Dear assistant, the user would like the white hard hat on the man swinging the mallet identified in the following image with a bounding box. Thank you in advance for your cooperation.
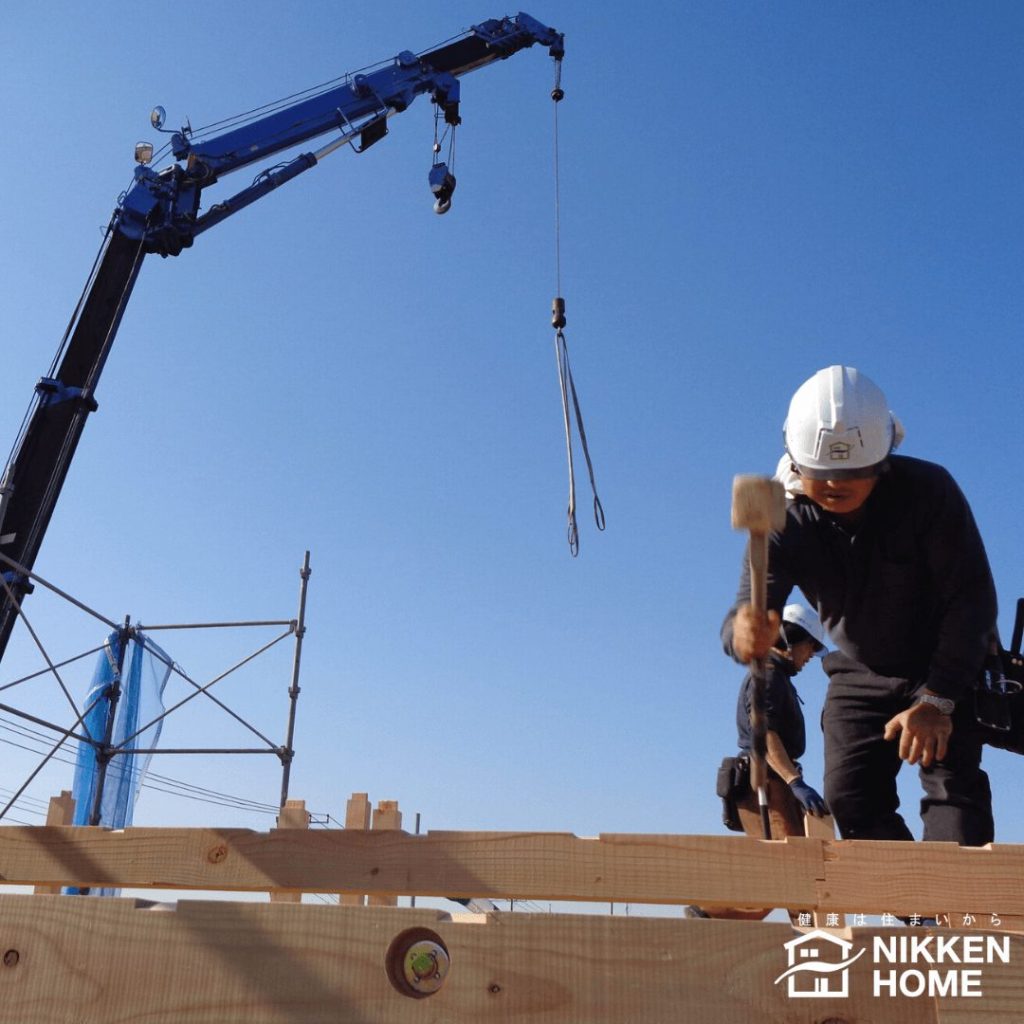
[782,367,903,480]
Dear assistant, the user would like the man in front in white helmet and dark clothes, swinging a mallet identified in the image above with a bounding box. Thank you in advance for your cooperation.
[722,366,996,846]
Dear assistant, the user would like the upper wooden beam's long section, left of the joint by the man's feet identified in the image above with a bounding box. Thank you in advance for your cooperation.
[0,825,822,906]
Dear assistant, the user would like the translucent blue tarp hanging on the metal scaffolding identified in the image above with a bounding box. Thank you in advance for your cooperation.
[66,632,172,894]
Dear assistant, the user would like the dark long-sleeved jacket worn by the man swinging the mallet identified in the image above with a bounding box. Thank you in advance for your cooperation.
[722,456,996,699]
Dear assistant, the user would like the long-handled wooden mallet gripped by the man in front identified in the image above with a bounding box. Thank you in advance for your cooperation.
[732,475,785,839]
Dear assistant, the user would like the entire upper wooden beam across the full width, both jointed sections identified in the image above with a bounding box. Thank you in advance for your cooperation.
[0,825,1024,919]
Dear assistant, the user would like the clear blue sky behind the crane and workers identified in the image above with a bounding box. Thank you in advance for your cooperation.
[0,0,1024,864]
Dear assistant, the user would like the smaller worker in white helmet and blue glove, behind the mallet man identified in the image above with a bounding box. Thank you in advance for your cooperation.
[736,604,828,839]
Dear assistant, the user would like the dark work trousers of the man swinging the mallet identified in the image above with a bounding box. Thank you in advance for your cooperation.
[821,652,994,846]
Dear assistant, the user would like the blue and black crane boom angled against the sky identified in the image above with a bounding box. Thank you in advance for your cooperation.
[0,13,564,658]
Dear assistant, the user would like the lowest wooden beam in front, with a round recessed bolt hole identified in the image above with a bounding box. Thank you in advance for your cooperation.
[6,895,1024,1024]
